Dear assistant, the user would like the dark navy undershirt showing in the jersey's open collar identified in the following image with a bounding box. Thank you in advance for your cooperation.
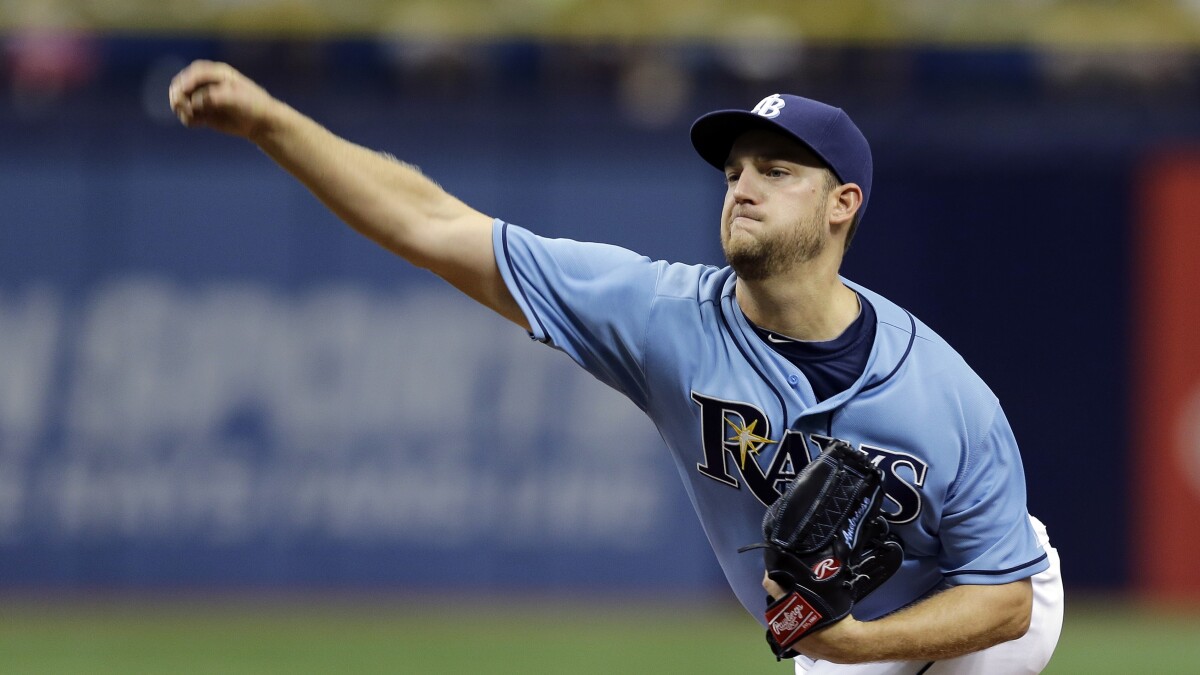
[746,295,875,401]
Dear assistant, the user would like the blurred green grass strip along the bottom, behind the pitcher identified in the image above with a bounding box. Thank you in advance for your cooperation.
[0,595,1200,675]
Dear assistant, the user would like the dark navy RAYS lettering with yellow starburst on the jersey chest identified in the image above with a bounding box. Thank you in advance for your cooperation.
[691,392,929,516]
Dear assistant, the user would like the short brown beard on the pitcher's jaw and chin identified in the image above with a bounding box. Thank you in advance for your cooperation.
[721,205,829,281]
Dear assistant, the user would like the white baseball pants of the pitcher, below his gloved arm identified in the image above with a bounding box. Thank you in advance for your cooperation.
[794,516,1063,675]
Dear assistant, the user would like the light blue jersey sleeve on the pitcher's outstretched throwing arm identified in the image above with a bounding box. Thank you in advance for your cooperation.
[492,220,665,410]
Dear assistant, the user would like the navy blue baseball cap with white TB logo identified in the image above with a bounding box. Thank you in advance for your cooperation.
[691,94,871,217]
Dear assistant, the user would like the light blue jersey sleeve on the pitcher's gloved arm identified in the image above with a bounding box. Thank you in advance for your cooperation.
[940,404,1050,585]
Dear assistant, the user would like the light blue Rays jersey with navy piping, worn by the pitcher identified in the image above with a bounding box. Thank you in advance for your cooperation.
[493,221,1049,621]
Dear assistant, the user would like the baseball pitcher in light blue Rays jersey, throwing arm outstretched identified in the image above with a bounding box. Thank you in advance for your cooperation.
[169,61,1063,675]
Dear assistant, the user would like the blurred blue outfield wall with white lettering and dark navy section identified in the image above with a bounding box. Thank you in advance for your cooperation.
[0,42,1198,591]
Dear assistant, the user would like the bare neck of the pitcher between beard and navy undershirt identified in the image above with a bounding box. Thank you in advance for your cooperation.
[736,265,859,341]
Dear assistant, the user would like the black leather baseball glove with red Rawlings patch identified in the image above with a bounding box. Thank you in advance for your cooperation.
[738,441,904,659]
